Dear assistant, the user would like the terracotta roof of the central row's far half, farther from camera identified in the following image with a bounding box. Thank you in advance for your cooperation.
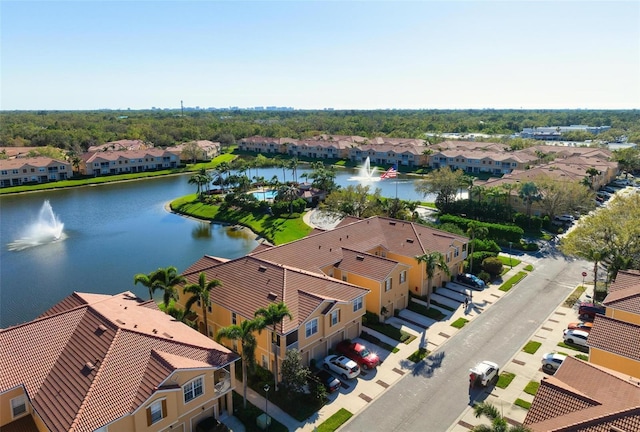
[253,216,468,272]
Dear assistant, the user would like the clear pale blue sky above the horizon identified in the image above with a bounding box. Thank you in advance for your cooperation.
[0,0,640,110]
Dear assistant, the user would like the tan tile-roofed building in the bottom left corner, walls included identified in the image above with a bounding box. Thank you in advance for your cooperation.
[0,292,238,432]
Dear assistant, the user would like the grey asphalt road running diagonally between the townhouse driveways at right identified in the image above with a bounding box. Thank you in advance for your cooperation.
[340,250,589,432]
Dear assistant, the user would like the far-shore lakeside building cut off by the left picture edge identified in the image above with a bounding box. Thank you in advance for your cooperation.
[0,156,73,187]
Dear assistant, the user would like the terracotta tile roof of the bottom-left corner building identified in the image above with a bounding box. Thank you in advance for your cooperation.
[0,292,238,431]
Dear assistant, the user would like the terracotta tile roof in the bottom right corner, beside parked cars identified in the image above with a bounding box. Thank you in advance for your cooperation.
[524,356,640,432]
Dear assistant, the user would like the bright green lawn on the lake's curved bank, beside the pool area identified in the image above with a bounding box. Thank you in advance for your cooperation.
[171,194,312,245]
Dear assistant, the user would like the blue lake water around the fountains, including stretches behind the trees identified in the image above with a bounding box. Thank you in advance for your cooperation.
[0,168,436,328]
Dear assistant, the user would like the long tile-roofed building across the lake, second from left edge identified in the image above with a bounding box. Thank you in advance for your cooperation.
[80,149,180,177]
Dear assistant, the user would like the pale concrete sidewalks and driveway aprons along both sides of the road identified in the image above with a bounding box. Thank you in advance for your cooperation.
[233,262,540,432]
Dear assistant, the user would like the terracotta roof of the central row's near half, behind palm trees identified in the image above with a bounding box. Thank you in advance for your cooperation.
[184,255,369,334]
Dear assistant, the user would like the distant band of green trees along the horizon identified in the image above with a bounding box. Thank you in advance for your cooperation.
[0,110,640,154]
